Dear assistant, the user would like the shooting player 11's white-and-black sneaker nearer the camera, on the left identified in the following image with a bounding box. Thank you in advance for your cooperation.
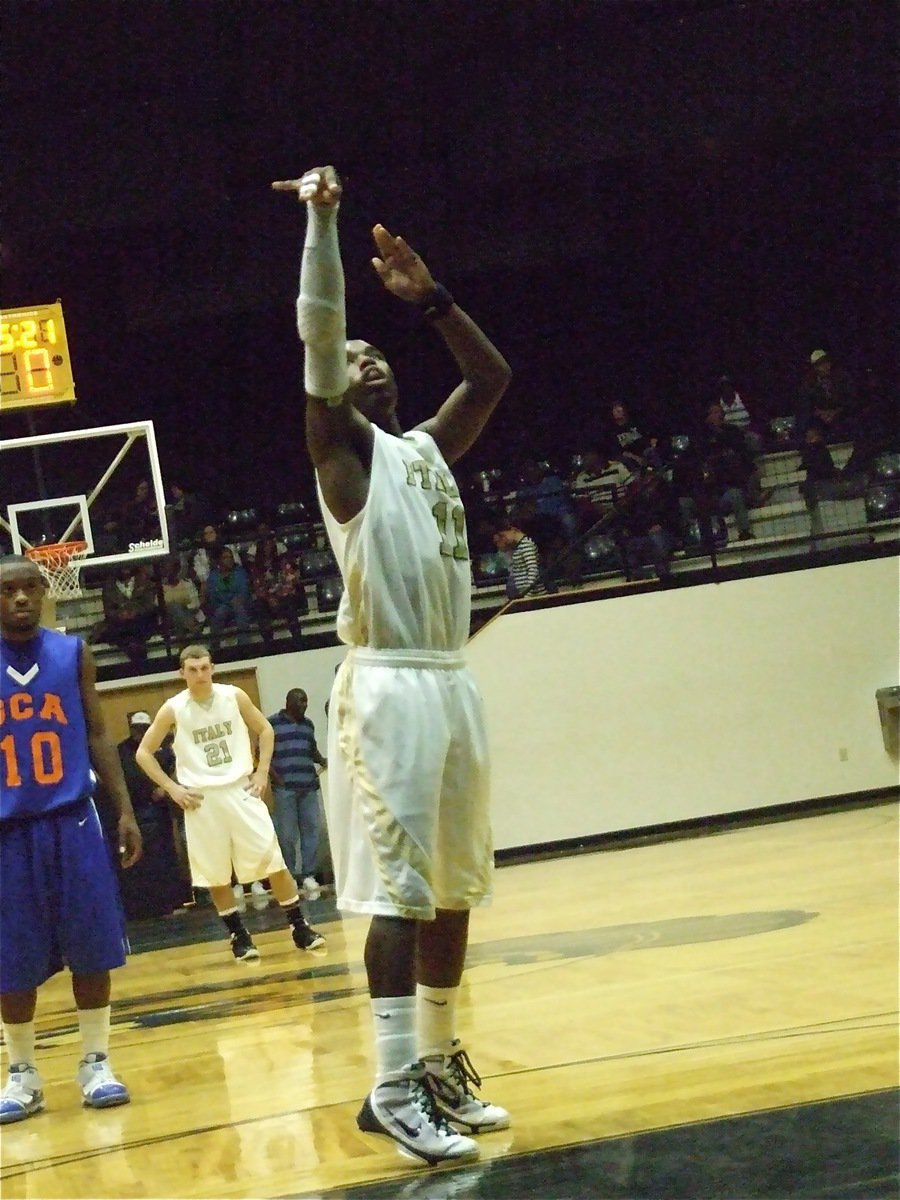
[356,1062,479,1165]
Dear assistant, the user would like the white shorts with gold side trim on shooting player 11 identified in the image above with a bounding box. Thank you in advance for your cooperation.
[325,647,493,920]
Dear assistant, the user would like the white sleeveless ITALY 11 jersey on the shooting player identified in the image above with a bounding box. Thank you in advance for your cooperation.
[319,425,472,650]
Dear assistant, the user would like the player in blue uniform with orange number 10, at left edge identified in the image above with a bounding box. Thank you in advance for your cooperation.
[0,554,140,1124]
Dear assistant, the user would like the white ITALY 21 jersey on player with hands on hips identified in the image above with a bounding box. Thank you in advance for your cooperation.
[169,683,253,787]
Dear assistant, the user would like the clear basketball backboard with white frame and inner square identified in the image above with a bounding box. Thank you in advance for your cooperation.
[0,421,169,566]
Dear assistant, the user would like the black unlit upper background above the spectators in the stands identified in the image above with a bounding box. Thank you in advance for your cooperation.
[0,0,898,506]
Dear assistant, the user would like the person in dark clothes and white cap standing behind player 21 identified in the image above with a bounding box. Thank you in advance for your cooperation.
[118,712,191,920]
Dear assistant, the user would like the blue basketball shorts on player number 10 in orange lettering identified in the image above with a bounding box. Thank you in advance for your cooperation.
[0,798,128,992]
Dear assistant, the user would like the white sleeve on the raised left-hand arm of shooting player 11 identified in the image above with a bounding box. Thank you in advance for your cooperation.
[296,204,348,398]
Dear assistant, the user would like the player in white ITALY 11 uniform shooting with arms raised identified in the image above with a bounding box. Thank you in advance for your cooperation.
[274,167,510,1163]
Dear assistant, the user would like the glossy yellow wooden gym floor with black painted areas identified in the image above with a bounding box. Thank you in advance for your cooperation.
[0,803,899,1200]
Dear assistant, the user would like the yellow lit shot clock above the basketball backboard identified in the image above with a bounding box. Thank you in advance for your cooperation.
[0,301,76,413]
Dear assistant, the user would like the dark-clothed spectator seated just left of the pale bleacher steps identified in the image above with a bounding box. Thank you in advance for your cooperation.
[672,401,755,541]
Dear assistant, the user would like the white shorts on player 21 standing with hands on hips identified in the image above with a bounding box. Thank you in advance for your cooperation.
[185,780,284,888]
